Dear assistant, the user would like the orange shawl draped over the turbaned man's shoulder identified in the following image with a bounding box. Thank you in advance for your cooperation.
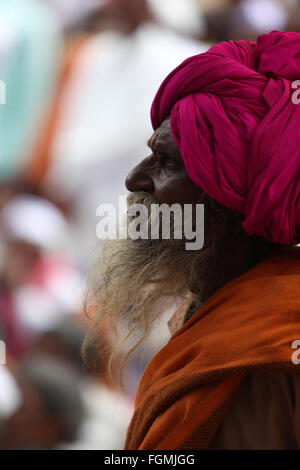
[125,247,300,450]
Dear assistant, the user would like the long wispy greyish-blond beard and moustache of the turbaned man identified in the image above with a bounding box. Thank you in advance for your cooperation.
[88,193,213,362]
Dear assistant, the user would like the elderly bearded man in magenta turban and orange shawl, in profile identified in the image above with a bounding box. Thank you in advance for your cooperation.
[91,31,300,450]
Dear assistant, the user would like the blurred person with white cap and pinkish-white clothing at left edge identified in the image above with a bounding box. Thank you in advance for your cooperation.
[0,194,82,358]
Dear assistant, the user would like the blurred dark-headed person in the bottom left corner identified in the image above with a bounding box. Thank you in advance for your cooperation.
[0,357,85,450]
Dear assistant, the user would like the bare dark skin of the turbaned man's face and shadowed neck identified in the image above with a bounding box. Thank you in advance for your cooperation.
[126,120,278,302]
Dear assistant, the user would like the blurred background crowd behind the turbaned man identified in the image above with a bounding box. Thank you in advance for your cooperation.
[0,0,300,449]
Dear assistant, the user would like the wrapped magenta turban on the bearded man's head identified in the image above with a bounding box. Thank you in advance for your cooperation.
[151,31,300,245]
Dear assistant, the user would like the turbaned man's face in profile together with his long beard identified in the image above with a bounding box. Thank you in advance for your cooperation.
[88,121,213,360]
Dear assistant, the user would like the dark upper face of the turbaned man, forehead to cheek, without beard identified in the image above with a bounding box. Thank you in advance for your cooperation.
[126,120,203,205]
